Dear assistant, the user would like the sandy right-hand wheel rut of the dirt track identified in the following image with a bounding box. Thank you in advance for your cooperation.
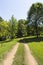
[24,44,38,65]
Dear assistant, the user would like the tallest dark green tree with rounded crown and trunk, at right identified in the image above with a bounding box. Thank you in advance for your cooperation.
[27,3,43,38]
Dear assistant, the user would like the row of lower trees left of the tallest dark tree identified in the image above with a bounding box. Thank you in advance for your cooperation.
[0,15,27,41]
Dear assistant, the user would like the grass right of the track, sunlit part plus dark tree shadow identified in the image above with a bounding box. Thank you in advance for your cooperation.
[19,36,43,65]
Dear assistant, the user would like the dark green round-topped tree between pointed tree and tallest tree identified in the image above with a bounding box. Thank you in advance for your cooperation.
[17,19,27,37]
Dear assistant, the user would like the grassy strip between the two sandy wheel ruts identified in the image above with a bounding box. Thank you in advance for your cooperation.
[12,43,25,65]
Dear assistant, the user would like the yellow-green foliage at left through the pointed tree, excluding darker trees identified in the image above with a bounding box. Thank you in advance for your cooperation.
[0,16,17,41]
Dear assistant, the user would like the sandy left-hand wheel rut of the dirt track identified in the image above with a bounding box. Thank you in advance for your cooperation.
[2,43,19,65]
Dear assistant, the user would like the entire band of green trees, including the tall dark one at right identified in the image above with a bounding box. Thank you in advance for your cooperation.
[0,3,43,41]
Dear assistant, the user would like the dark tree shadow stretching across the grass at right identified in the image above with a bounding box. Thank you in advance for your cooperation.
[18,37,43,43]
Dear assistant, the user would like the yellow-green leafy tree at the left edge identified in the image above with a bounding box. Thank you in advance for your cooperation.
[0,21,8,40]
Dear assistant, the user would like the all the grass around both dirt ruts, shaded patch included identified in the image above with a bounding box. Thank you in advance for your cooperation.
[0,36,43,65]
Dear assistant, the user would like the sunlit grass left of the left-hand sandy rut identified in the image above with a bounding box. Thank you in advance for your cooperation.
[0,39,17,63]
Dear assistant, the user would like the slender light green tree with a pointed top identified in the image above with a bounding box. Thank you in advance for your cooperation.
[10,15,17,39]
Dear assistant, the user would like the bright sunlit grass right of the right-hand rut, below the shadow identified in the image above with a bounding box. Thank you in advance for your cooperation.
[28,41,43,65]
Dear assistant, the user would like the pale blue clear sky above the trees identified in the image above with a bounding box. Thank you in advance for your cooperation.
[0,0,43,20]
